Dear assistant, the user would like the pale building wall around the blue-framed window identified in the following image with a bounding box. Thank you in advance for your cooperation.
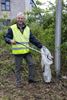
[0,0,25,19]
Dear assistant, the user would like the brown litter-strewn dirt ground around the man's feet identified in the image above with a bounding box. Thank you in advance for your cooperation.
[0,50,67,100]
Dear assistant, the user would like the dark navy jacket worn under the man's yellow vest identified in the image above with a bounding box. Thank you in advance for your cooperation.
[5,25,42,48]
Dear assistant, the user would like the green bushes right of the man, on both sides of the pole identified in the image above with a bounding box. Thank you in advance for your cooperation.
[27,2,67,67]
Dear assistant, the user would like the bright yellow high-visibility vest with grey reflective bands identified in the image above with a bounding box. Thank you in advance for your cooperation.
[11,24,30,54]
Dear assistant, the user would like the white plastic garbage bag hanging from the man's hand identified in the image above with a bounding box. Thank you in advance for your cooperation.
[41,46,53,83]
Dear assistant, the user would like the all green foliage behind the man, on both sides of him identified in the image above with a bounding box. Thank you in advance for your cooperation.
[0,0,67,76]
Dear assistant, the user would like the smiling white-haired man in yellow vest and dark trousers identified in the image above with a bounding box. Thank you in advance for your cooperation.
[5,12,42,87]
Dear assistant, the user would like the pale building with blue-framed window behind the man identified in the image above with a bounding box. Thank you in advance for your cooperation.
[0,0,33,19]
